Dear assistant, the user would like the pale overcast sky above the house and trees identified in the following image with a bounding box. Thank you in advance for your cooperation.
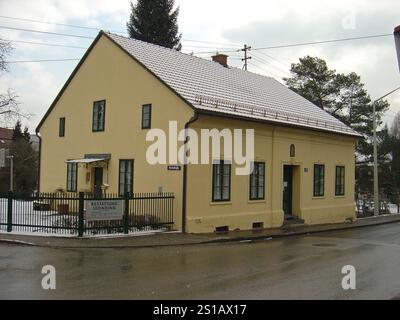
[0,0,400,132]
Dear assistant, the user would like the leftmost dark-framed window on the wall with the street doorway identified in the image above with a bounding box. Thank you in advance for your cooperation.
[212,161,231,202]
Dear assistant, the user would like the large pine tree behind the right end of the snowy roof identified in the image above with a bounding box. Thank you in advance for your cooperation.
[284,56,389,162]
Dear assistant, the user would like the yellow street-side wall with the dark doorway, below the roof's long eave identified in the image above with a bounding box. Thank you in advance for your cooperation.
[187,116,356,233]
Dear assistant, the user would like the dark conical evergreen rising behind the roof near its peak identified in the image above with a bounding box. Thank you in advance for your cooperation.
[127,0,182,51]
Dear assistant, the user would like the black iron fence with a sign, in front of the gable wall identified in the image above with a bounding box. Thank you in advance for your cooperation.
[0,192,174,237]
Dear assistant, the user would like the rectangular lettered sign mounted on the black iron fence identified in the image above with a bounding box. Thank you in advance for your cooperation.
[86,199,124,221]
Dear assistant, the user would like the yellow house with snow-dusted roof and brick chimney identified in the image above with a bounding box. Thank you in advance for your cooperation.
[37,32,358,233]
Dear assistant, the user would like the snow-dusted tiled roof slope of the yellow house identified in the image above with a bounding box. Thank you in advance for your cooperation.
[105,33,358,136]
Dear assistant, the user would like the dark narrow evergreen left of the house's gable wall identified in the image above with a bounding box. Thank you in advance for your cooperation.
[10,121,37,193]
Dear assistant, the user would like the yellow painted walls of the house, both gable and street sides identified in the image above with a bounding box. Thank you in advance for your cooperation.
[40,36,355,233]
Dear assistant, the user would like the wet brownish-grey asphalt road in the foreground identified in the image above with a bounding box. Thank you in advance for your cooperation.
[0,223,400,299]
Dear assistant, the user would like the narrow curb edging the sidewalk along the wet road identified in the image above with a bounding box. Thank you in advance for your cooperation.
[0,217,400,249]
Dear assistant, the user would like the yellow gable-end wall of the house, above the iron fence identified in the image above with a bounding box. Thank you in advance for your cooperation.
[40,36,193,229]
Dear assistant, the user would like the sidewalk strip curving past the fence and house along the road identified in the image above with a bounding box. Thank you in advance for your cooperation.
[0,214,400,249]
